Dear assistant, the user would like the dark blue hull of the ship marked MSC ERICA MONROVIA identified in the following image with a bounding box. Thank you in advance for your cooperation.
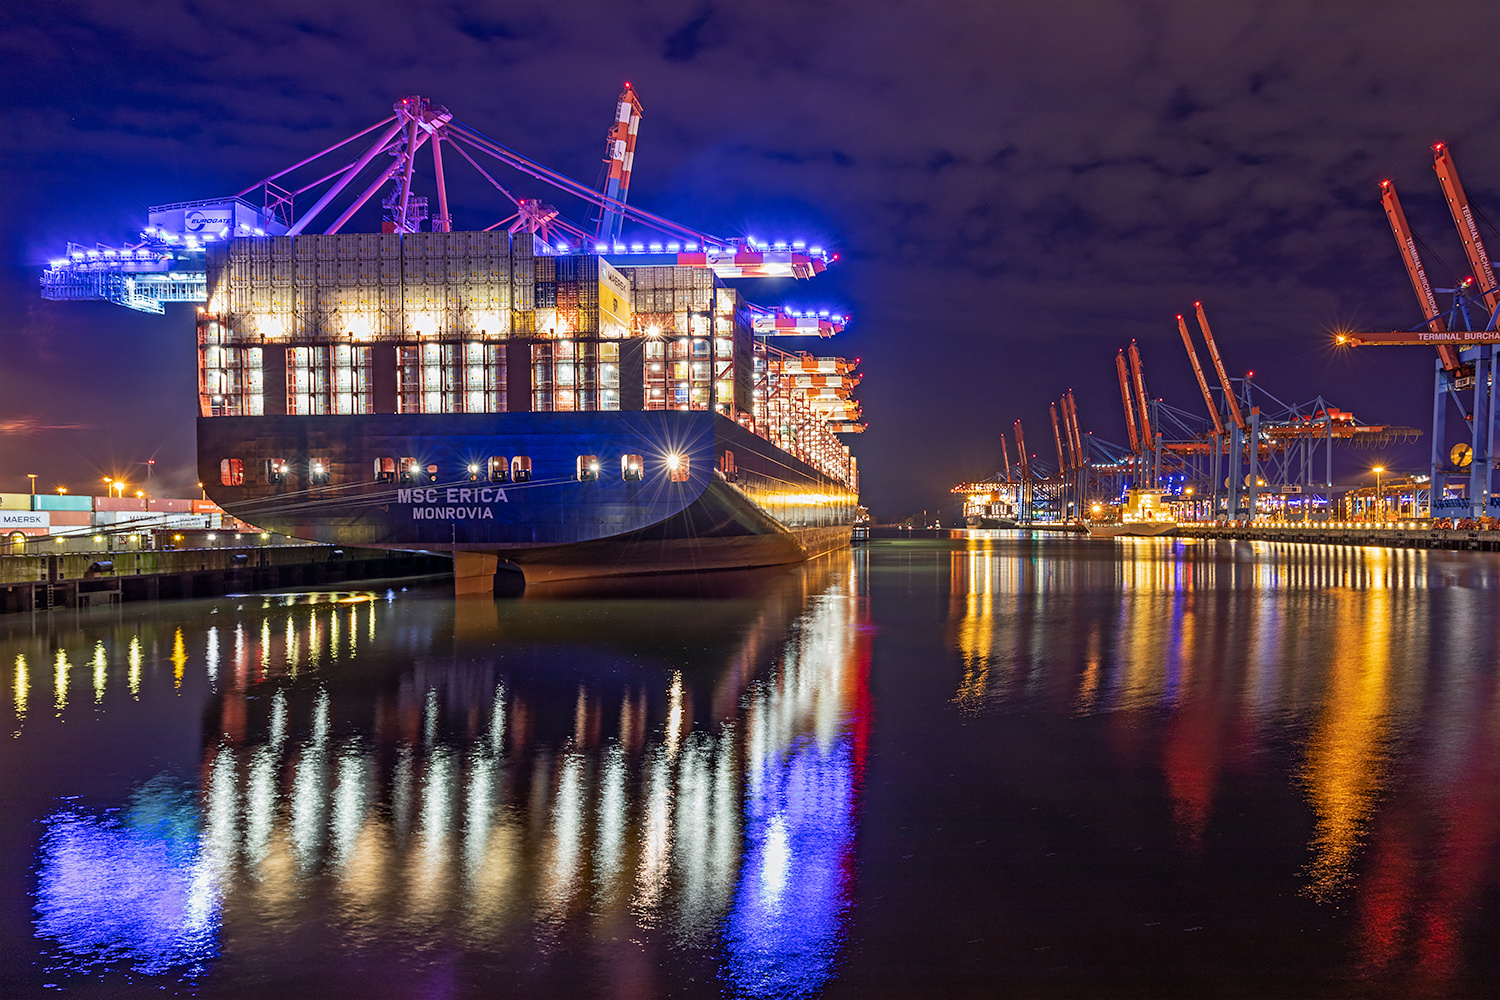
[198,411,858,582]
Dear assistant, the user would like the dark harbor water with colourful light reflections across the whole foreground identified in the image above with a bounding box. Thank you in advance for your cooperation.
[0,531,1500,1000]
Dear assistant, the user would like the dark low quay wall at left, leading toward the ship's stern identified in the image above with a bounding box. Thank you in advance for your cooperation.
[0,546,453,613]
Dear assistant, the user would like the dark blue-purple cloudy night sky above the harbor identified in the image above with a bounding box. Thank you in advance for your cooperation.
[0,0,1500,519]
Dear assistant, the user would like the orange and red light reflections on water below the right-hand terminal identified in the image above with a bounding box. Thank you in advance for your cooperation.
[948,537,1500,991]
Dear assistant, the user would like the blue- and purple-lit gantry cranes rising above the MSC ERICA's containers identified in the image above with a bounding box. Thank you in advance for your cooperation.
[41,84,837,310]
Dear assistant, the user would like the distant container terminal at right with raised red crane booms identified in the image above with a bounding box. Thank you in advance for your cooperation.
[953,144,1500,549]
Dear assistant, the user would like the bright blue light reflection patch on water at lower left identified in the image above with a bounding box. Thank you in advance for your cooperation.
[35,780,219,976]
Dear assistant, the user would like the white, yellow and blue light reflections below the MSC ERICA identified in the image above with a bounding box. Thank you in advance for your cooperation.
[15,555,869,996]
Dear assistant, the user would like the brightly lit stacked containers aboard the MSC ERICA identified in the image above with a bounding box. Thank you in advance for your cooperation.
[198,232,858,481]
